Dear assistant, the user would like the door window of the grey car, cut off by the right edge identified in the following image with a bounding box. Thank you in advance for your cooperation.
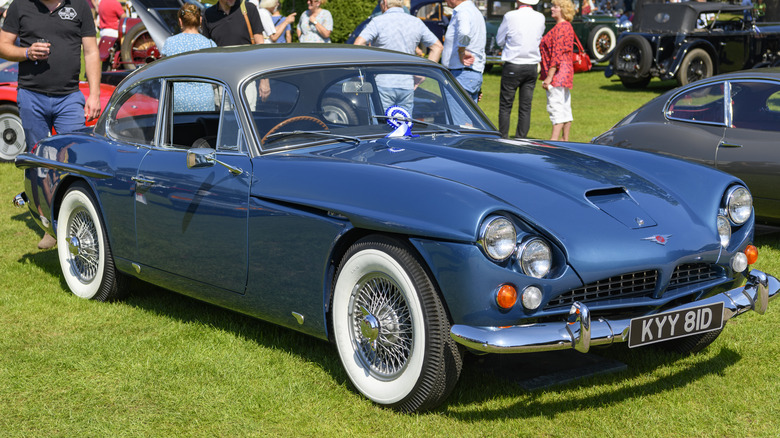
[731,81,780,131]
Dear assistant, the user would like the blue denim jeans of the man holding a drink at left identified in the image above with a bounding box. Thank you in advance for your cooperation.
[16,88,86,151]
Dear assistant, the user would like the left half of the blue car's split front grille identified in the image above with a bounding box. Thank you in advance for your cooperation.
[546,270,658,308]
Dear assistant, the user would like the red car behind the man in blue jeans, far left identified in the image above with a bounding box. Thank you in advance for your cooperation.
[0,61,115,161]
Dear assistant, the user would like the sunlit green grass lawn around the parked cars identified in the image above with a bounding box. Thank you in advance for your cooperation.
[0,68,780,437]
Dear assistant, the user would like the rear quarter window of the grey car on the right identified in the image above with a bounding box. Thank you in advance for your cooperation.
[666,83,725,125]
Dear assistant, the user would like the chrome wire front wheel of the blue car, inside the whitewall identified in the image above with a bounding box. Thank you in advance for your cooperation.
[349,275,414,380]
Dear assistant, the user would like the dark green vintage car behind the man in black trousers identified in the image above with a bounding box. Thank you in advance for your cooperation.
[485,0,631,65]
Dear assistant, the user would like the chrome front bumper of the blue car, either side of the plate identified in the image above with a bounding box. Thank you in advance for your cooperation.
[450,270,780,353]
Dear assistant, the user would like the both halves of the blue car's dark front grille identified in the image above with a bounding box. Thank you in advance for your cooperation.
[545,263,720,309]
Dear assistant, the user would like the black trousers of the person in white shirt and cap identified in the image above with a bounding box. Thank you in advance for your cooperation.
[498,62,536,138]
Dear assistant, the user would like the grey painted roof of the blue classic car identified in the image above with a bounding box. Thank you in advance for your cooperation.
[115,44,443,94]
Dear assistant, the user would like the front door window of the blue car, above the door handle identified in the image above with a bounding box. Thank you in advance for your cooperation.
[163,80,233,149]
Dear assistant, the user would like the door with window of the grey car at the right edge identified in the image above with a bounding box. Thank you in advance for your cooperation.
[717,80,780,218]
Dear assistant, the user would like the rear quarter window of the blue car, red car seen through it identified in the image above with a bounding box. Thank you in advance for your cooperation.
[107,79,162,145]
